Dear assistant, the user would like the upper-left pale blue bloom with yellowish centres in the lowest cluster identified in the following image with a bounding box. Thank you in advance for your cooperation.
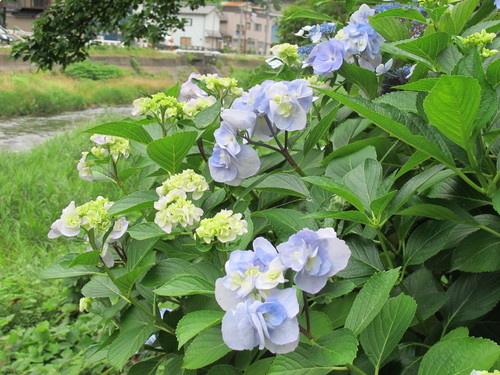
[215,237,286,310]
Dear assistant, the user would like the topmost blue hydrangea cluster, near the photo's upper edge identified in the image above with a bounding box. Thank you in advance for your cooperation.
[299,4,392,77]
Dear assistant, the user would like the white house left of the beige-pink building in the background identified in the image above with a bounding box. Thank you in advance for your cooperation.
[171,4,224,50]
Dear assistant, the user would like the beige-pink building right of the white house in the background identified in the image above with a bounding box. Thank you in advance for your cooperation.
[221,1,281,55]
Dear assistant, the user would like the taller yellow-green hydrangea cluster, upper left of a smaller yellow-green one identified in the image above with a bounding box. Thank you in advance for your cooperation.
[154,169,208,233]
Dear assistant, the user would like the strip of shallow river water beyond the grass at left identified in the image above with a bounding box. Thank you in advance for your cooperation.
[0,107,132,151]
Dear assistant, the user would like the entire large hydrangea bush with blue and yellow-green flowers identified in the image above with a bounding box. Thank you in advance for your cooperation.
[43,0,500,375]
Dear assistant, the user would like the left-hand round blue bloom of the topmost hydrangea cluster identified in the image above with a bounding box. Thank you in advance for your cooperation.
[305,39,345,77]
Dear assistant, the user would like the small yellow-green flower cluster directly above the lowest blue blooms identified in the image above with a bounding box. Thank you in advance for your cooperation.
[196,210,248,243]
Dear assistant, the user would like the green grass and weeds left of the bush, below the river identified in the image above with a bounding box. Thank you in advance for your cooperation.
[0,118,124,375]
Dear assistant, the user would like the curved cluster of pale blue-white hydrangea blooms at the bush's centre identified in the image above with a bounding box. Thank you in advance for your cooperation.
[208,79,313,186]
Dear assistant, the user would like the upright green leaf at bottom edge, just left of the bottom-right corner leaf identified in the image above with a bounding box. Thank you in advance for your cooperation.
[359,294,417,369]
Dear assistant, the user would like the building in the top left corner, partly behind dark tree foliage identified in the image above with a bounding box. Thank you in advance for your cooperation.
[0,0,53,31]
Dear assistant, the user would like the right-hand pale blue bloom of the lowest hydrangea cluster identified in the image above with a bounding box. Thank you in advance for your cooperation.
[278,228,351,294]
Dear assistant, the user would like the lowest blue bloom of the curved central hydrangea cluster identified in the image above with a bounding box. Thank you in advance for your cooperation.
[208,144,260,186]
